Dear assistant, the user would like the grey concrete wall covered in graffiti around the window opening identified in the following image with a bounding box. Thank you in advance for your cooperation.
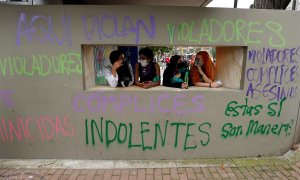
[0,6,300,159]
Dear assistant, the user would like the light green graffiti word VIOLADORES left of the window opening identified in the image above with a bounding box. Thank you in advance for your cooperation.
[0,52,82,77]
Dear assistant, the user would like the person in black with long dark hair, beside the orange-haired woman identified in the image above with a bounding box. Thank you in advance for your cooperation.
[163,55,189,89]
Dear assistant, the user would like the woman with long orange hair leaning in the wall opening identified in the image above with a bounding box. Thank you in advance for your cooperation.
[190,51,221,88]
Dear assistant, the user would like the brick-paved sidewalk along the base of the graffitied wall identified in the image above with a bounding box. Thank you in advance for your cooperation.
[0,144,300,180]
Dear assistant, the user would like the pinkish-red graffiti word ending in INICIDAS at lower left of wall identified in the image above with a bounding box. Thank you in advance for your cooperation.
[0,115,76,143]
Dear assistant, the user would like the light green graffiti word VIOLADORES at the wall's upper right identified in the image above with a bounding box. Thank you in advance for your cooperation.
[167,18,286,48]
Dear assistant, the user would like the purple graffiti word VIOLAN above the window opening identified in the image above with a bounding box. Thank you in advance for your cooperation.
[82,15,156,43]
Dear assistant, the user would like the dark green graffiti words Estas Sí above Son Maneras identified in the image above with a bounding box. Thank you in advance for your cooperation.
[225,98,286,117]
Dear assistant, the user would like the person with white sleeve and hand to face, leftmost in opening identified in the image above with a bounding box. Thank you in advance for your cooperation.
[104,50,134,88]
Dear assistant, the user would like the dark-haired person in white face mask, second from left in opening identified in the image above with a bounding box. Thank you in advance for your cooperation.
[134,47,160,89]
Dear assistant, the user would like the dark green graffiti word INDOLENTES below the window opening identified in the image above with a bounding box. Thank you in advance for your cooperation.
[85,117,212,151]
